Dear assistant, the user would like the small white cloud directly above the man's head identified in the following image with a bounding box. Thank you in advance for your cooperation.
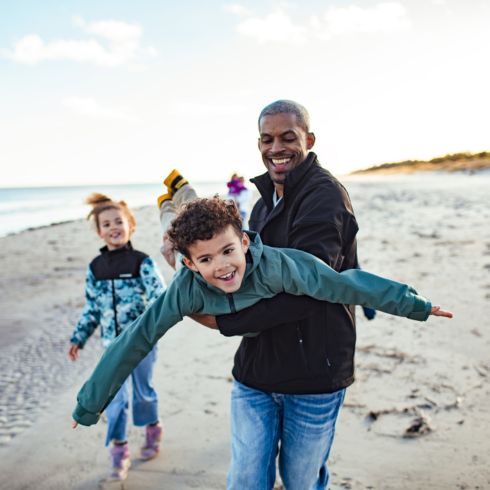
[236,10,305,44]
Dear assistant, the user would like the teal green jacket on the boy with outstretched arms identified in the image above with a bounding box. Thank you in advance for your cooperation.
[73,232,431,425]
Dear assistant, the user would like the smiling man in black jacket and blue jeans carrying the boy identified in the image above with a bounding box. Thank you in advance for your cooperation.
[217,100,358,490]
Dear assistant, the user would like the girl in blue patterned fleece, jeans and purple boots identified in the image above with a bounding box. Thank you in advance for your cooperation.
[68,193,164,480]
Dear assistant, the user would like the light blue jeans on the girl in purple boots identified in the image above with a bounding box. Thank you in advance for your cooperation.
[105,347,158,446]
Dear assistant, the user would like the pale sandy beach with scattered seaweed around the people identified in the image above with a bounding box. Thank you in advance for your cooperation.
[0,174,490,490]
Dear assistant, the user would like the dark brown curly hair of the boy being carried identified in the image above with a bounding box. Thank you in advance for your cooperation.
[167,196,243,258]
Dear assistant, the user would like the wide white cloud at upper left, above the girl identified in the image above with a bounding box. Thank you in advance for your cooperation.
[2,17,156,67]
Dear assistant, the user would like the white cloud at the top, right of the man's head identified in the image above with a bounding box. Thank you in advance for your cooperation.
[312,2,410,38]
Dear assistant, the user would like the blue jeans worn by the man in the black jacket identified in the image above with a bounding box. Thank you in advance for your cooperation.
[227,381,345,490]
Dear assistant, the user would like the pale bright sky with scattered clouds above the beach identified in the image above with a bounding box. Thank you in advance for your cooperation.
[0,0,490,186]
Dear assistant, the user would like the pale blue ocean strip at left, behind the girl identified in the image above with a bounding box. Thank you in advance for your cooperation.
[0,182,227,237]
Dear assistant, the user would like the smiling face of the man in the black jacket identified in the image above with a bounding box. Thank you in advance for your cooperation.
[259,113,315,195]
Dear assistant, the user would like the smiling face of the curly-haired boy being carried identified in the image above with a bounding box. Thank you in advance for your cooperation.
[184,225,250,293]
